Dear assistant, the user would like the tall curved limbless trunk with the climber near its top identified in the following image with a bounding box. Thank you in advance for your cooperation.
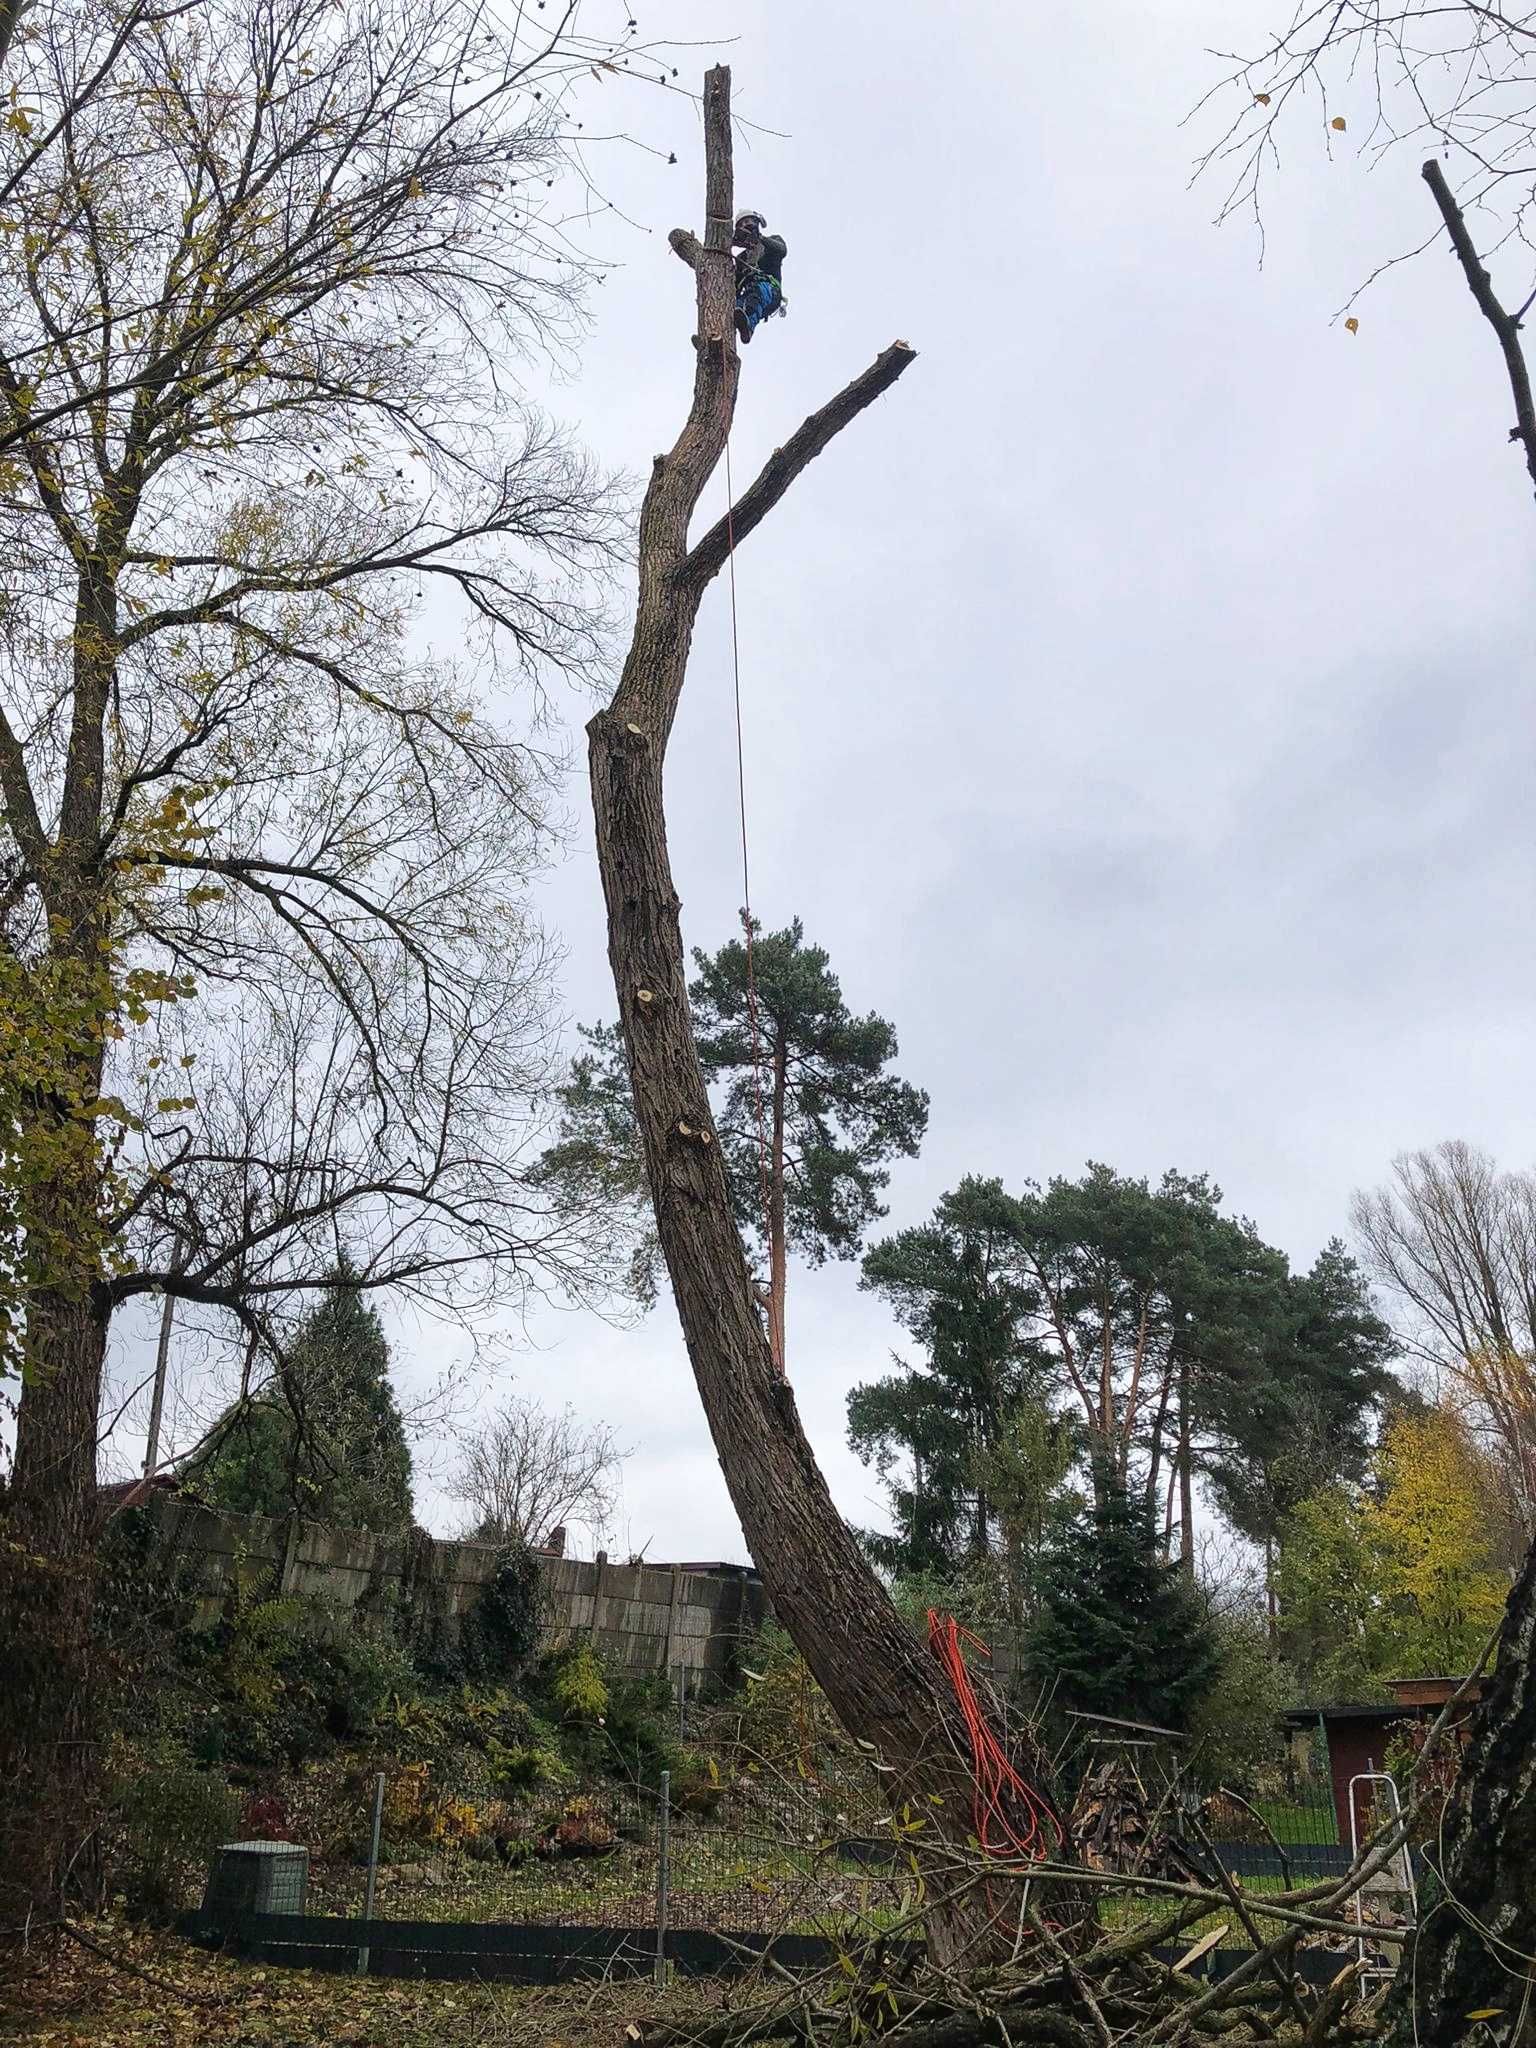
[588,68,1048,1956]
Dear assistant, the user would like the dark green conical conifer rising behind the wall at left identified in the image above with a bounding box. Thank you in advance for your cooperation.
[188,1264,412,1534]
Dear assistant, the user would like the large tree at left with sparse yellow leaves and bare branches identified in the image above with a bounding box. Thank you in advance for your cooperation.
[0,0,675,1896]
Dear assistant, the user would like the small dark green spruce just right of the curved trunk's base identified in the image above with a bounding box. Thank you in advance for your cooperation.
[1028,1464,1221,1729]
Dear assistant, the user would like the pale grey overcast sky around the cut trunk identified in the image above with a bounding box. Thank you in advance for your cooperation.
[108,0,1536,1559]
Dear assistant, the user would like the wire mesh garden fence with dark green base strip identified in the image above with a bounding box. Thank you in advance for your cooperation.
[171,1708,1392,1980]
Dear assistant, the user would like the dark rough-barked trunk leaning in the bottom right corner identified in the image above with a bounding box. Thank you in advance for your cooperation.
[1382,1546,1536,2048]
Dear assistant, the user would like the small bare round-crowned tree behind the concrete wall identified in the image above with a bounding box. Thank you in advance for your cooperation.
[449,1399,625,1544]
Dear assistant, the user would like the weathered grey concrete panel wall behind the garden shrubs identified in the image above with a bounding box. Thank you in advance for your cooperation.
[154,1499,764,1690]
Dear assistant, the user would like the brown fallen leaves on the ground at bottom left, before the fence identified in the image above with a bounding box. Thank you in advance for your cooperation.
[0,1921,721,2048]
